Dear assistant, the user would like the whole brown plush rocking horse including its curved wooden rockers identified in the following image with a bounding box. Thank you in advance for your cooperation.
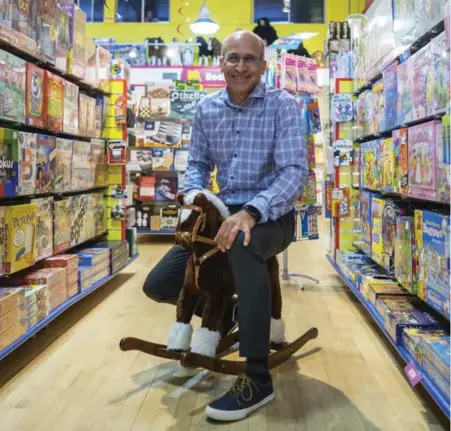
[120,190,318,375]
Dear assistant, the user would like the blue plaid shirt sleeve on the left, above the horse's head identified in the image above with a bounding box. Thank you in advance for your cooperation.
[183,103,214,193]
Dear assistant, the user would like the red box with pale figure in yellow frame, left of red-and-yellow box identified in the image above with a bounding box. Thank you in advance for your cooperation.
[25,63,45,128]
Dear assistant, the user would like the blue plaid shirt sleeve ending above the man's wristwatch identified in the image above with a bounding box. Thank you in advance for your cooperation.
[248,97,308,223]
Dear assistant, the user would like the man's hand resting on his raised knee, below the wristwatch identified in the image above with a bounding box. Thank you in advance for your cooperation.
[215,210,256,252]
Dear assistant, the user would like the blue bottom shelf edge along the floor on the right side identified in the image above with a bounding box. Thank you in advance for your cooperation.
[326,254,450,419]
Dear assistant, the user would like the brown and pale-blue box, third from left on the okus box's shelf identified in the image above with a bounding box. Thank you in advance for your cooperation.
[36,134,56,194]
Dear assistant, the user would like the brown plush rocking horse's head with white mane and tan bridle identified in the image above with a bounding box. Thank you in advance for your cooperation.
[175,190,229,248]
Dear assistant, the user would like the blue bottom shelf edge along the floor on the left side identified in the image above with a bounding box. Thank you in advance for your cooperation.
[0,254,139,360]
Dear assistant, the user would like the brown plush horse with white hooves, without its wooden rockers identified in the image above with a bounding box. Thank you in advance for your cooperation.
[167,190,285,357]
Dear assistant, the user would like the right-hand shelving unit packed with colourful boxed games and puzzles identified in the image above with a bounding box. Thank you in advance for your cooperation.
[325,0,451,418]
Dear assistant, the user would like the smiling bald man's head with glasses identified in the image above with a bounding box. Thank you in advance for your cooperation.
[221,36,266,98]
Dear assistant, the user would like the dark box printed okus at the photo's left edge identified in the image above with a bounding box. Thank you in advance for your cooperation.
[0,128,19,197]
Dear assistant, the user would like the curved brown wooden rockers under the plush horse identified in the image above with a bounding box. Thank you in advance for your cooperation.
[119,328,318,375]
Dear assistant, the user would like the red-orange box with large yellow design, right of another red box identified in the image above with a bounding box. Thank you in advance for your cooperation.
[44,71,65,132]
